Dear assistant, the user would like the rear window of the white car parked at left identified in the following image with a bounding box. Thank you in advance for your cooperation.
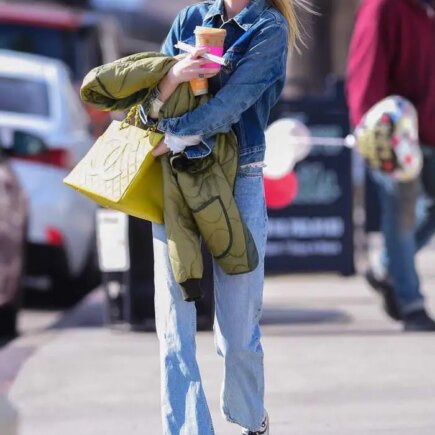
[0,76,50,117]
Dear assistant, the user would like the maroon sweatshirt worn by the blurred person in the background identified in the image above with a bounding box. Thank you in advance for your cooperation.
[347,0,435,146]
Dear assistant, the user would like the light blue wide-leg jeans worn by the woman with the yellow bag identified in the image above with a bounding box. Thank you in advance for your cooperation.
[153,167,267,435]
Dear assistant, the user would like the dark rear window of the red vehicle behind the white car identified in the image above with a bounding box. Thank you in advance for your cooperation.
[0,23,78,80]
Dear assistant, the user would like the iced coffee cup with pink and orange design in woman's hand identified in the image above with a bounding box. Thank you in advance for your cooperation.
[190,26,227,96]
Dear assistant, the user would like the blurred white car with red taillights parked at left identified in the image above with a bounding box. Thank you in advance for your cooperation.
[0,50,97,299]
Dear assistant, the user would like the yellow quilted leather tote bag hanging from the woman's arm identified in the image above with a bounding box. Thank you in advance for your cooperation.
[63,109,163,223]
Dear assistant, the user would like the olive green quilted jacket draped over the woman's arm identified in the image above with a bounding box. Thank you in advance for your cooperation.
[81,53,258,301]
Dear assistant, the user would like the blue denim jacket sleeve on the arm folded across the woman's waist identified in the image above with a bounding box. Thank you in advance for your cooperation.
[158,22,288,157]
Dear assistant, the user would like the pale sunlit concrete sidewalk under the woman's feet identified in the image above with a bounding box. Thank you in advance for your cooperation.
[2,248,435,435]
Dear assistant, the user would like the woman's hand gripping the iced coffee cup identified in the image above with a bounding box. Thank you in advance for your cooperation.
[168,48,220,85]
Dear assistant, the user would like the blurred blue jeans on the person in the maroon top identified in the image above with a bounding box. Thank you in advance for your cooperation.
[372,147,435,314]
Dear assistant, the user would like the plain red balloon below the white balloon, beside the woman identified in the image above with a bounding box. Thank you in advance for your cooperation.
[264,172,299,208]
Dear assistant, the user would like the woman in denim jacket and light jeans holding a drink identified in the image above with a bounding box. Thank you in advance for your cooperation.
[141,0,300,435]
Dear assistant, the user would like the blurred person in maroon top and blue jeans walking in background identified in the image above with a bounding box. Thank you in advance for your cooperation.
[347,0,435,331]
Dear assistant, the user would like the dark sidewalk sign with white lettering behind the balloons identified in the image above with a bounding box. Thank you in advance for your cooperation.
[266,85,355,275]
